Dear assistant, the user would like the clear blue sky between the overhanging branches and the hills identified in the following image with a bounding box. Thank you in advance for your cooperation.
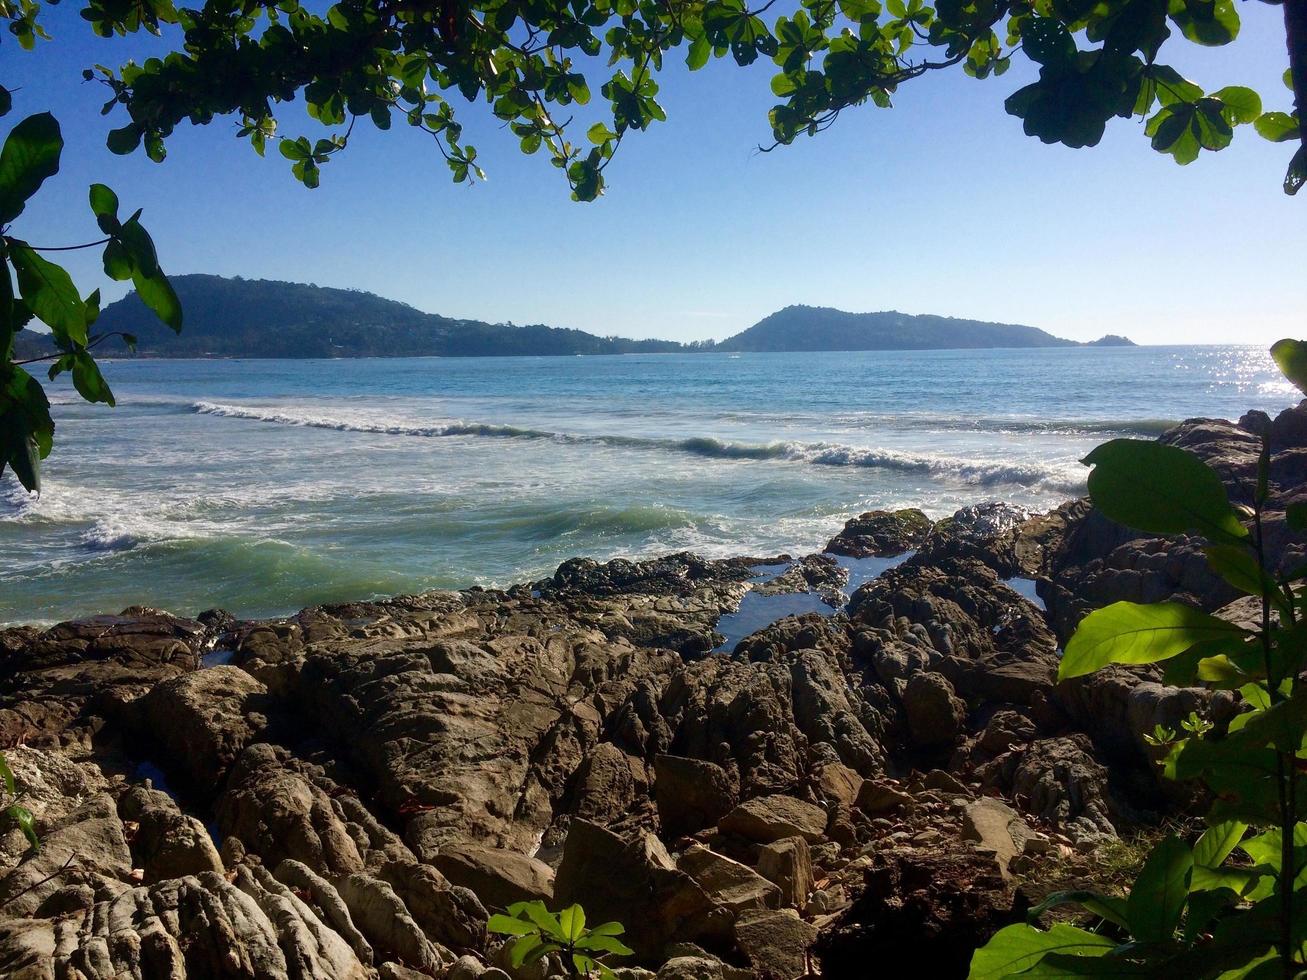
[0,3,1307,344]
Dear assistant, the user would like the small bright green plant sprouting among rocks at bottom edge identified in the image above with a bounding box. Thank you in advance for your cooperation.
[486,902,634,980]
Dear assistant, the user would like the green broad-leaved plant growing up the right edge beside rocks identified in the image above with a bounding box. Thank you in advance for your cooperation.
[971,342,1307,977]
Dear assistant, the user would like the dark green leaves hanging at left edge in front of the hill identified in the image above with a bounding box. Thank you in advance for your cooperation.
[0,101,182,491]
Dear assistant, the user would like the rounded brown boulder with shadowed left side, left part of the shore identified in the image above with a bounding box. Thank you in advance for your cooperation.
[137,666,272,794]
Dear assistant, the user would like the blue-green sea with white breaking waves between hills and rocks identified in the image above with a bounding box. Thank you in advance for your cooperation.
[0,346,1298,623]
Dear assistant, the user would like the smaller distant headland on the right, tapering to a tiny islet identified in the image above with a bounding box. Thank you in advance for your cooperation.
[714,306,1134,351]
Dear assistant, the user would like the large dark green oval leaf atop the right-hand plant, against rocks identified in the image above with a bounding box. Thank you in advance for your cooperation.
[1085,439,1248,541]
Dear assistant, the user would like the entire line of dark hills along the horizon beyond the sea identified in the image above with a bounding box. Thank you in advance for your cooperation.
[18,273,1133,358]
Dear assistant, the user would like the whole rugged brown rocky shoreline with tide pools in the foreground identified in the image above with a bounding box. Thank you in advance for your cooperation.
[0,406,1307,980]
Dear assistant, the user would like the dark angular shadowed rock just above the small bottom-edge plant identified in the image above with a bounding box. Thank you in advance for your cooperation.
[554,819,731,959]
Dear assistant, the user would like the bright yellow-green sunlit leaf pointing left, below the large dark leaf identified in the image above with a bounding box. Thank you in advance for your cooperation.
[1057,602,1246,681]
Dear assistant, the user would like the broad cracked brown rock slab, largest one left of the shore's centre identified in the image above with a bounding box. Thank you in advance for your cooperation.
[298,593,680,861]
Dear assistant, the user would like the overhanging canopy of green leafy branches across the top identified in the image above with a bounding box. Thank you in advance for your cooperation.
[0,0,1307,200]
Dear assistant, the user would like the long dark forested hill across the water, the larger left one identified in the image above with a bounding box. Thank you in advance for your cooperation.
[95,276,689,358]
